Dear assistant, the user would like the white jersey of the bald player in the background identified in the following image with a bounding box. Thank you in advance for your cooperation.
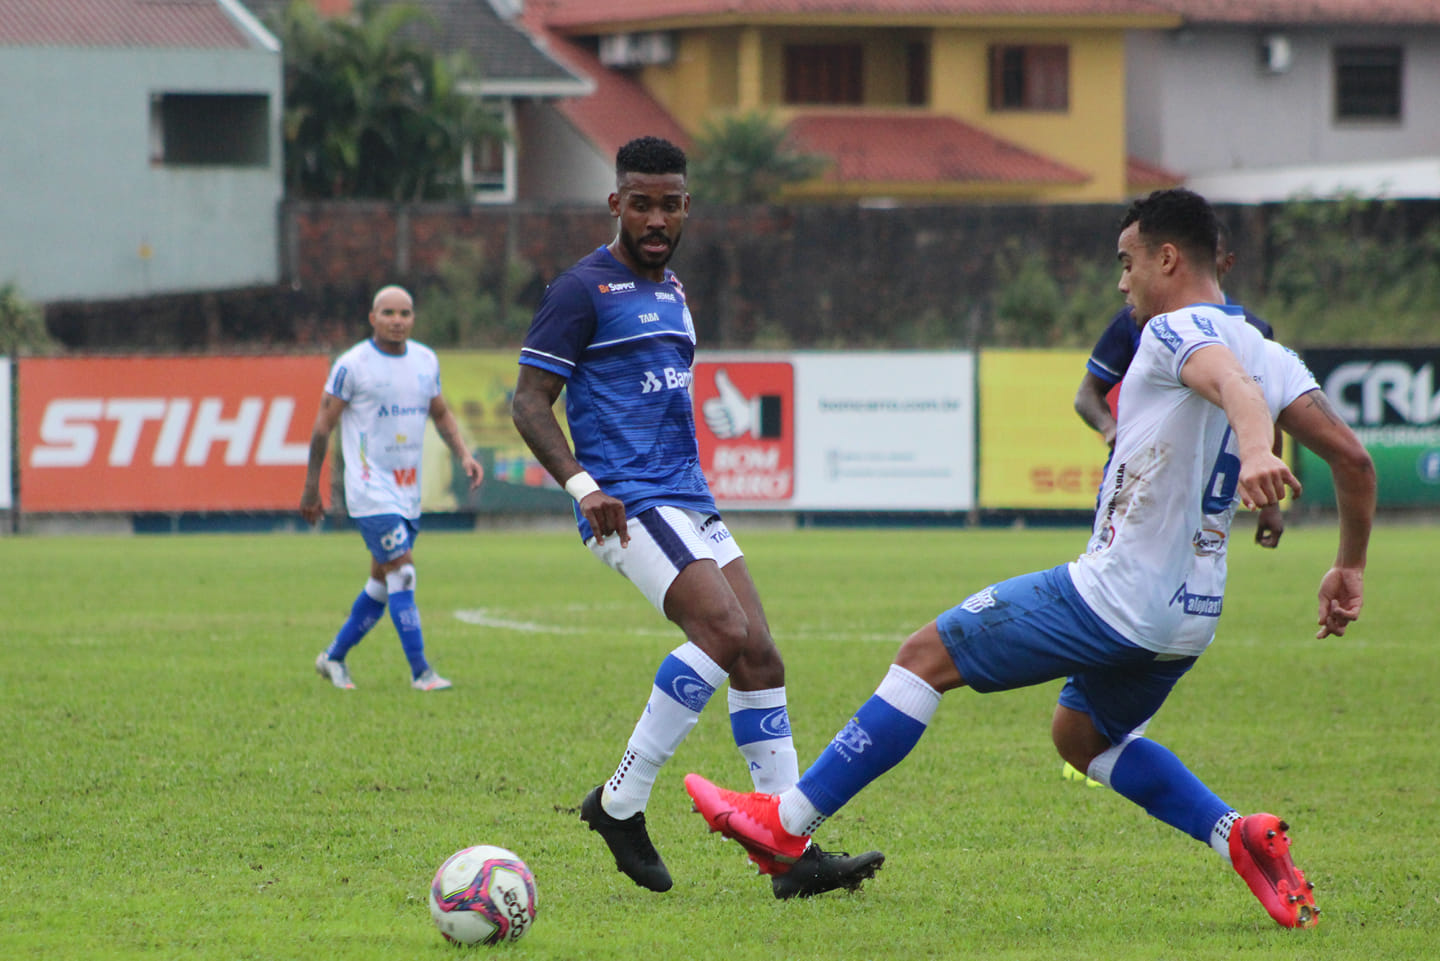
[325,340,441,519]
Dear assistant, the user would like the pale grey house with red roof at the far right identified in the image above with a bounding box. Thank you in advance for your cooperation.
[1125,0,1440,203]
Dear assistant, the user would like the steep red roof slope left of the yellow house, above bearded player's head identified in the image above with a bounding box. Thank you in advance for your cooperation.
[530,23,691,157]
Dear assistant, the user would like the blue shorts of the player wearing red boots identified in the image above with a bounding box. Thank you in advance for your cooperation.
[936,565,1195,743]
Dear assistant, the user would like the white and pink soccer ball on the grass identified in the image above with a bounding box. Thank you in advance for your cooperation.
[431,844,536,944]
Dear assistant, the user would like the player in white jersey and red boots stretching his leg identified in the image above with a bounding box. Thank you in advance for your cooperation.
[685,190,1375,928]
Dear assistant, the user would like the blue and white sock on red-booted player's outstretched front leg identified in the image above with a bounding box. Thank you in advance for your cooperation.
[780,664,940,836]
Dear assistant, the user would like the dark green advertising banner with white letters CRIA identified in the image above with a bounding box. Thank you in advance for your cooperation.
[1297,347,1440,507]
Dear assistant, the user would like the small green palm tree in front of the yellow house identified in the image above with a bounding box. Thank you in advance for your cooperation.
[690,111,829,203]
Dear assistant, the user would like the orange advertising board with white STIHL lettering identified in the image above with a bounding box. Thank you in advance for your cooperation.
[19,354,330,511]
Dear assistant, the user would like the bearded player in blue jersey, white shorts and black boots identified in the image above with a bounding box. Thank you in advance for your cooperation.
[513,137,884,898]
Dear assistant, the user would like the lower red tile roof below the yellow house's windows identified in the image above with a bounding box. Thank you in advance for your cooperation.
[789,112,1089,184]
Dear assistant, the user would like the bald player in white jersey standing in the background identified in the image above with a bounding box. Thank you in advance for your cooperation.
[300,287,484,690]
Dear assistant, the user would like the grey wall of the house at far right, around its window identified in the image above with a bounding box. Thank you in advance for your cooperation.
[1126,27,1440,174]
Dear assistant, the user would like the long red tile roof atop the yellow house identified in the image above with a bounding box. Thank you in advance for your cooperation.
[538,0,1169,30]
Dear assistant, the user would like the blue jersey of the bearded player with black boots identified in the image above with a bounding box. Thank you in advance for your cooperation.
[520,246,716,540]
